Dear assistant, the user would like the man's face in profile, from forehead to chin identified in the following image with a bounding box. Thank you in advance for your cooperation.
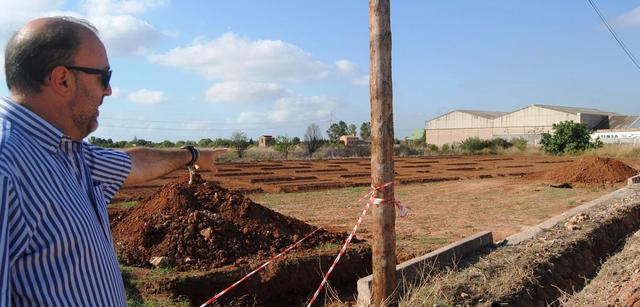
[70,35,111,138]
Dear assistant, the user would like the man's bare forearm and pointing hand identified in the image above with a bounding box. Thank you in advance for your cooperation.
[124,147,227,185]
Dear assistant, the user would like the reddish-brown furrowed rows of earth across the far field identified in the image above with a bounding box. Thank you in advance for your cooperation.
[113,156,616,203]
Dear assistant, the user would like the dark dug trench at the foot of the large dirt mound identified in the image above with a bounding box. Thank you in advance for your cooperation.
[168,243,371,307]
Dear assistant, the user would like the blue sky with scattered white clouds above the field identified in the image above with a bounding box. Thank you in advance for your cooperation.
[0,0,640,142]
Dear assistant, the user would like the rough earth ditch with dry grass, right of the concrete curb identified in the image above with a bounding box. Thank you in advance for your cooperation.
[427,184,640,306]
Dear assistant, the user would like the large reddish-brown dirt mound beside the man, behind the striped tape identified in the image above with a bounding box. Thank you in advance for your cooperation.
[112,176,347,271]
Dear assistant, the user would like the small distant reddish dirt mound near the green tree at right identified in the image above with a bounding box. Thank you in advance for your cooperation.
[529,156,637,186]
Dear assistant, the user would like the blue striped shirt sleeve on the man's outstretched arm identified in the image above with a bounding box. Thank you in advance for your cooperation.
[83,143,131,203]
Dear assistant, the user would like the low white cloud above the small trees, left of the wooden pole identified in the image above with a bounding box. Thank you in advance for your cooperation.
[236,96,338,124]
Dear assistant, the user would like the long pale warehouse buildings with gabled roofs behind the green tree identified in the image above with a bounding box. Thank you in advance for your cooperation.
[425,104,640,146]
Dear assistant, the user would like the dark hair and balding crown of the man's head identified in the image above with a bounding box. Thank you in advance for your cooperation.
[4,17,97,96]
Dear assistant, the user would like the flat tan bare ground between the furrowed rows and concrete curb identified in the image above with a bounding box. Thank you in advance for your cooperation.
[251,178,613,262]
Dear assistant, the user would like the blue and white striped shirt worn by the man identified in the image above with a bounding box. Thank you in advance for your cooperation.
[0,97,131,306]
